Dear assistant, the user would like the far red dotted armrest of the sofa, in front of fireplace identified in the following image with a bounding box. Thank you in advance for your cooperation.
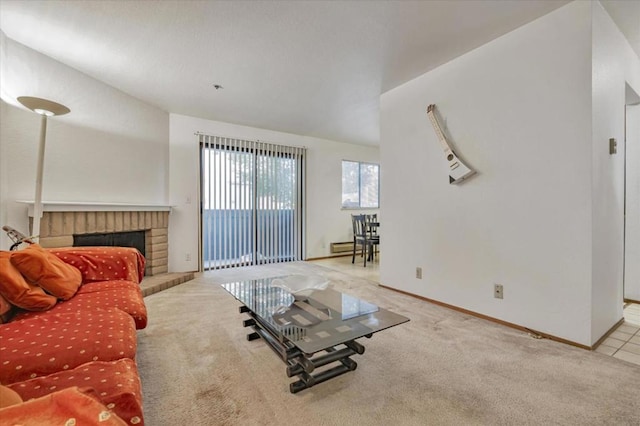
[48,247,145,283]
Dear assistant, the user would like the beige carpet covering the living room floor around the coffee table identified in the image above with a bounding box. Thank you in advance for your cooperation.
[137,262,640,426]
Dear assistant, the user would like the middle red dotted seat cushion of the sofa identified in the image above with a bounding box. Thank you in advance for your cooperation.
[0,308,137,385]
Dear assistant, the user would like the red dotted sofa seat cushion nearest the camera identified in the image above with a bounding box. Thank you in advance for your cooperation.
[9,358,143,425]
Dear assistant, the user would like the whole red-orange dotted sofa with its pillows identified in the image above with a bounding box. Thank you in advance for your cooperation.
[0,244,147,425]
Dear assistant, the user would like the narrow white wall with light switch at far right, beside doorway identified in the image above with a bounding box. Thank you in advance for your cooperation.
[591,2,640,342]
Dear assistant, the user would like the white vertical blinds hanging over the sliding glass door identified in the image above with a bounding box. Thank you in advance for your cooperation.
[198,134,306,269]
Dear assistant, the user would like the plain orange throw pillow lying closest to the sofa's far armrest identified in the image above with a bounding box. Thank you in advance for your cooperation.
[11,244,82,300]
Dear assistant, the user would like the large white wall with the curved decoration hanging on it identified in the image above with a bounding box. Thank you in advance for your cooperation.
[380,2,592,345]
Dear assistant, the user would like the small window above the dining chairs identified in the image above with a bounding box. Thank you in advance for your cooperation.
[342,160,380,209]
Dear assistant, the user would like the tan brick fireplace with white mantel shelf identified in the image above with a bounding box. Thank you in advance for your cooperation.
[25,203,171,275]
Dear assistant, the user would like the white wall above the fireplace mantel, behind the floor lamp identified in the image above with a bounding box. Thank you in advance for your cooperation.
[0,33,169,249]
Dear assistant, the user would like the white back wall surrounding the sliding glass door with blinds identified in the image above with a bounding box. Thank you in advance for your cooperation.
[169,114,379,272]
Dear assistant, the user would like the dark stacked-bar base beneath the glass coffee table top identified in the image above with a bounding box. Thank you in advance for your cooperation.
[240,306,372,393]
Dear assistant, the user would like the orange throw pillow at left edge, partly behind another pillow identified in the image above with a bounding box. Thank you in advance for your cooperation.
[0,251,57,311]
